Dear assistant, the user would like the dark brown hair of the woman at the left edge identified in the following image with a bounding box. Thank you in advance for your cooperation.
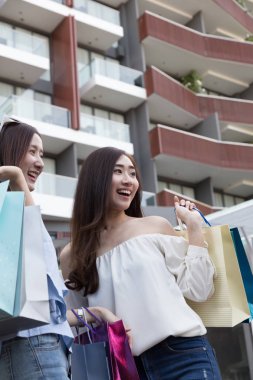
[0,119,40,166]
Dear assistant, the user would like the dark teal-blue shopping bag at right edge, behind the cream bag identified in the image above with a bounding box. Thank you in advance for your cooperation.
[230,227,253,321]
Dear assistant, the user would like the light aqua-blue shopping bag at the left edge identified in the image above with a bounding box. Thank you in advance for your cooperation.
[0,181,24,321]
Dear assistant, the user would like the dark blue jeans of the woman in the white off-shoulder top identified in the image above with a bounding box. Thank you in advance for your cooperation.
[135,336,221,380]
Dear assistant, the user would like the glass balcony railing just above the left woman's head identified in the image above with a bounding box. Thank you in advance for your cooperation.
[0,95,70,128]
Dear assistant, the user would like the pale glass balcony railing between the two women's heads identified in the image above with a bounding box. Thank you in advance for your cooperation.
[36,173,77,198]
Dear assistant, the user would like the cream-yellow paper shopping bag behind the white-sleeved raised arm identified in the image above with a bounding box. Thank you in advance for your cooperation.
[176,225,250,327]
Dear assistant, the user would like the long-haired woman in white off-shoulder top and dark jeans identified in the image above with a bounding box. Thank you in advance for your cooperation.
[61,147,221,380]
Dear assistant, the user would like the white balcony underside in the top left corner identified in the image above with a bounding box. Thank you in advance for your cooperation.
[0,0,70,33]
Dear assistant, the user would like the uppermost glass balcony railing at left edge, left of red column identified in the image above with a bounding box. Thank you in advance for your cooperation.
[0,22,49,58]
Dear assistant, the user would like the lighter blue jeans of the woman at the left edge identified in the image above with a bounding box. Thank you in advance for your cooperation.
[0,334,69,380]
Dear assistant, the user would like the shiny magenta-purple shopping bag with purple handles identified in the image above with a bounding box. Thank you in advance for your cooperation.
[72,307,140,380]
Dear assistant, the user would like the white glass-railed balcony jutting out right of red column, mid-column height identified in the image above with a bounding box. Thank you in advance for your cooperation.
[79,59,146,112]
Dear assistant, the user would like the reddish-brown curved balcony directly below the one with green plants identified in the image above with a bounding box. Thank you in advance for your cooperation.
[149,125,253,197]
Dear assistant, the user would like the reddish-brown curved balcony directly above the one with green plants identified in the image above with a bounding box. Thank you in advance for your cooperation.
[139,13,253,96]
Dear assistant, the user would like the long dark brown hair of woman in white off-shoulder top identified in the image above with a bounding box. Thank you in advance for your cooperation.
[67,147,142,296]
